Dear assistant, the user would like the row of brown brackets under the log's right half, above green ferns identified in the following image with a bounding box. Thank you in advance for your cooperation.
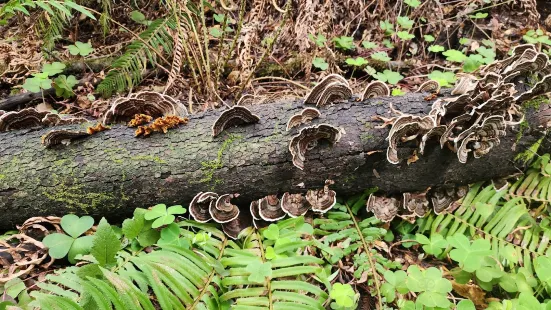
[366,186,469,222]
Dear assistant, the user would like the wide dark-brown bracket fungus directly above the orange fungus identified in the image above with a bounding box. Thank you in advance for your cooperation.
[103,91,188,124]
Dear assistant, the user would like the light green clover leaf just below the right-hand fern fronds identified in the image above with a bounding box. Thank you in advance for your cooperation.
[448,234,492,272]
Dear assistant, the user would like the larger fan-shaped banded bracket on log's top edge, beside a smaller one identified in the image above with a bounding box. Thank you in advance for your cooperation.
[304,74,352,107]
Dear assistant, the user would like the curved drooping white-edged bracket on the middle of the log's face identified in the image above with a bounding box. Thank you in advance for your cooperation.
[289,124,342,170]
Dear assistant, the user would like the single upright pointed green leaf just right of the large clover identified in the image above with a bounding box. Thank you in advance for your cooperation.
[90,218,121,267]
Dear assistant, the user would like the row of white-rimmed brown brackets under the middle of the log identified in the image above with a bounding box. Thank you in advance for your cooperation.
[189,180,337,239]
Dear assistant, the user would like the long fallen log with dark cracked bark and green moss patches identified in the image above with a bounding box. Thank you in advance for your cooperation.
[0,93,551,229]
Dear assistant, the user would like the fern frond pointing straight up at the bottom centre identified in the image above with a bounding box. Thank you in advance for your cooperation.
[220,218,328,310]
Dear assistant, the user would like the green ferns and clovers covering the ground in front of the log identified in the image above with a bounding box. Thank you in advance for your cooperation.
[0,155,551,309]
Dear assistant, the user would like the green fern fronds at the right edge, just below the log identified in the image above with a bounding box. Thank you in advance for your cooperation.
[418,155,551,271]
